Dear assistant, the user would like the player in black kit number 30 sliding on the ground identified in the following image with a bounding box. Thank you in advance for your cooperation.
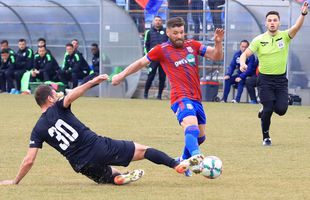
[0,74,191,185]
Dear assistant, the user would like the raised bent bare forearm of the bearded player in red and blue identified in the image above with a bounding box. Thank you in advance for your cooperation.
[204,28,224,61]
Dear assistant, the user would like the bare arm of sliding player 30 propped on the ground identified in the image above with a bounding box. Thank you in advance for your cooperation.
[0,148,39,185]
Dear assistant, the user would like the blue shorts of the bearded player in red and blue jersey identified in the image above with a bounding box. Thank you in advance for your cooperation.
[171,98,206,124]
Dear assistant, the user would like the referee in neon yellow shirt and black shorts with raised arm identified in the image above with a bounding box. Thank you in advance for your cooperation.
[240,2,308,146]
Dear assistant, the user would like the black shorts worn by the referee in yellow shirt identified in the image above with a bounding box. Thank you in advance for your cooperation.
[257,74,288,103]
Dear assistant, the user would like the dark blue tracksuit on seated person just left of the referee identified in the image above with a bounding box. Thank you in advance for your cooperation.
[223,50,257,102]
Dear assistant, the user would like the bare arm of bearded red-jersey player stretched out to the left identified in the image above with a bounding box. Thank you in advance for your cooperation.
[112,56,150,85]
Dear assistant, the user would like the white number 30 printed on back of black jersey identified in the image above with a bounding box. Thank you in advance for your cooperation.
[48,119,79,150]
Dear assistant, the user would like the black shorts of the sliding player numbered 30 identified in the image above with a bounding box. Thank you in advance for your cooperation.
[80,137,135,183]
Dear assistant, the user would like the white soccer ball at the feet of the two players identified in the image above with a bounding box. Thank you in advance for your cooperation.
[201,156,223,179]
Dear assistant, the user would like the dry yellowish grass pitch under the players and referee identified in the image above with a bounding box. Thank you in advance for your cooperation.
[0,94,310,200]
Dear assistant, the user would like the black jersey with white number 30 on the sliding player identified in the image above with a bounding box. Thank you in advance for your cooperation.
[29,99,99,171]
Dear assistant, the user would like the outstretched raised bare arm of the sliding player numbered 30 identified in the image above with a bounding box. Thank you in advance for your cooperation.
[64,74,109,108]
